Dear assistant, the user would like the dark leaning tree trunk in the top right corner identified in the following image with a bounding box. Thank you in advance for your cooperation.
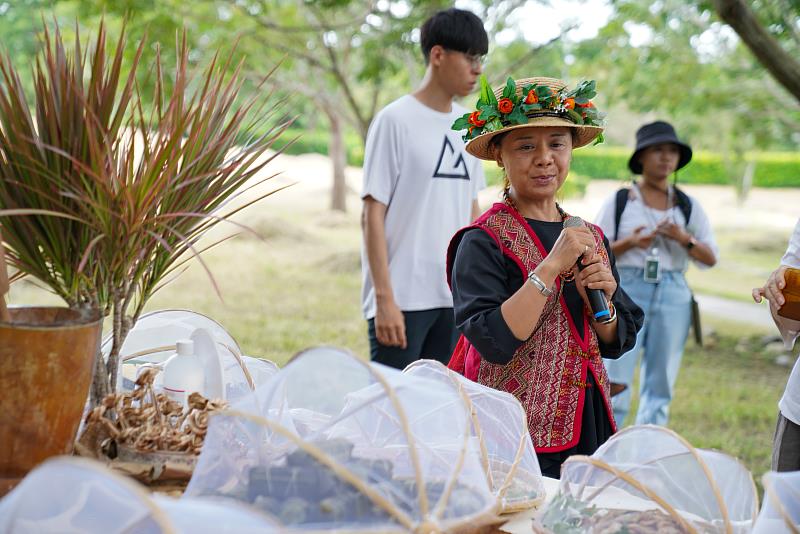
[713,0,800,102]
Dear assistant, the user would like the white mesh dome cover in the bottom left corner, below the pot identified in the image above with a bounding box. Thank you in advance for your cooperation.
[0,456,280,534]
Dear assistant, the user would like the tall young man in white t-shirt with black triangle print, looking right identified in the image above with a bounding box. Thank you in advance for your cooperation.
[361,8,489,369]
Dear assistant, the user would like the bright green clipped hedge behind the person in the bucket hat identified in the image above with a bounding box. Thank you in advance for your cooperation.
[571,147,800,187]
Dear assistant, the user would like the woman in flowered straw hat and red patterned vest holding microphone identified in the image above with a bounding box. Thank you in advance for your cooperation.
[447,74,642,478]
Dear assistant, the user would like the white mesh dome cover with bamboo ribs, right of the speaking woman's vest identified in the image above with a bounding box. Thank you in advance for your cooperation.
[541,425,758,533]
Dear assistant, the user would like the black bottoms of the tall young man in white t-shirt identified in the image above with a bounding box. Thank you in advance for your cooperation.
[367,308,458,369]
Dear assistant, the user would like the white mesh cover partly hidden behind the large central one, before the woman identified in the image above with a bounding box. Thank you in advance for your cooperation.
[404,360,545,513]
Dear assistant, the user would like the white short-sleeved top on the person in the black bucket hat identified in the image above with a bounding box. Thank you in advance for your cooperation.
[595,185,719,272]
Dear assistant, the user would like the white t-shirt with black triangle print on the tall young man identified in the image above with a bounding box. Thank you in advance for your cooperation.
[361,95,486,319]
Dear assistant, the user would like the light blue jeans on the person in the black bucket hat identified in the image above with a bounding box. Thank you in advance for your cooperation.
[605,267,692,426]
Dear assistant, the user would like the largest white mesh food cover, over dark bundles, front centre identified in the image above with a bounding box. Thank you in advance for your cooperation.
[184,348,497,532]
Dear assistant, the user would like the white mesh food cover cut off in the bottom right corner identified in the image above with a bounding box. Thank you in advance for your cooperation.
[753,471,800,534]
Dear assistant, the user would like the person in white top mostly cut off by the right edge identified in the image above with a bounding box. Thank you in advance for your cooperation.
[753,220,800,471]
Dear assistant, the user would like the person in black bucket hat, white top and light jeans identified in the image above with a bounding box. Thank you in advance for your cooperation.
[596,121,717,425]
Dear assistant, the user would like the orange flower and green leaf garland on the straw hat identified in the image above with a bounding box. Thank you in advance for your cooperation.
[452,76,604,143]
